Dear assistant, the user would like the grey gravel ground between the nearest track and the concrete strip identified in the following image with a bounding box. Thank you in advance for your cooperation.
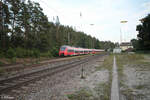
[1,56,109,100]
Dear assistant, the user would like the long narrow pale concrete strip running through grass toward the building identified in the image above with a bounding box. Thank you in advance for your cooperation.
[111,56,119,100]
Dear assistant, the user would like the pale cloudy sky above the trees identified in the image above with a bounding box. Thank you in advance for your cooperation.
[33,0,150,42]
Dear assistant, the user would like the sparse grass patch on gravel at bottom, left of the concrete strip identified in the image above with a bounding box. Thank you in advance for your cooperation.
[67,83,110,100]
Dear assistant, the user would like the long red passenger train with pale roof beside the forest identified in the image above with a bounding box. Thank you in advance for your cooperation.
[59,45,104,56]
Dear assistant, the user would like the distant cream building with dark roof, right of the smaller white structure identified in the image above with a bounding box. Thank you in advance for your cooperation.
[120,42,133,51]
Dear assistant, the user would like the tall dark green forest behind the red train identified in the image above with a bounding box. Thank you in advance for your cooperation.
[0,0,115,57]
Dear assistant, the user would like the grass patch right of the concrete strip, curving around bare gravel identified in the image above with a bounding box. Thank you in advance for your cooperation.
[116,54,150,100]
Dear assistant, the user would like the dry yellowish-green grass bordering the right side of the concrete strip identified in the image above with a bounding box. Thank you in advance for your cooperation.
[116,53,145,100]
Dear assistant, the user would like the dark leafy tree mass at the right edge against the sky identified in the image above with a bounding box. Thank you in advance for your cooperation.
[131,14,150,51]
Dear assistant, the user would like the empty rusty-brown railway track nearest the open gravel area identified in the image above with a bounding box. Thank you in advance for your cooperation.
[0,54,104,94]
